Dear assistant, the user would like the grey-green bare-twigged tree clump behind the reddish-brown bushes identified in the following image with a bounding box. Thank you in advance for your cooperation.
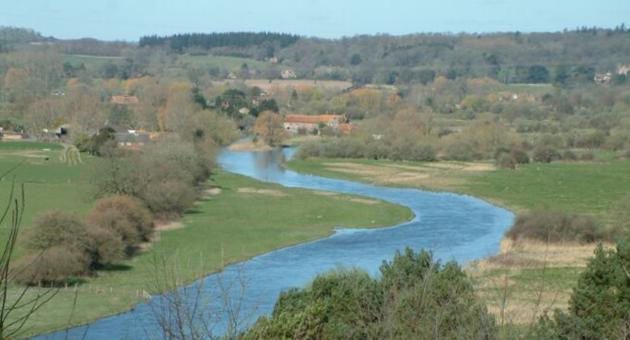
[95,137,215,219]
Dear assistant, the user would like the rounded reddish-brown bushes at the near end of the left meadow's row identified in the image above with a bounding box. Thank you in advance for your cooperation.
[16,196,153,285]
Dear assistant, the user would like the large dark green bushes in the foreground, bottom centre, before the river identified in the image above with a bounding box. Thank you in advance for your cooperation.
[242,249,496,339]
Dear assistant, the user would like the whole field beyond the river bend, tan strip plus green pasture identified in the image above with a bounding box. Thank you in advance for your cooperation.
[287,159,630,219]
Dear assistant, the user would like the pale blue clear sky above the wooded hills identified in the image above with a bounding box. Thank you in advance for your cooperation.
[0,0,630,41]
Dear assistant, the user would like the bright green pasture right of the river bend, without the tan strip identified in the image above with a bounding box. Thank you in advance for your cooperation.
[465,161,630,220]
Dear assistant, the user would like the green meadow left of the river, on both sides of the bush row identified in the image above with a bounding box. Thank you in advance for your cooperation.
[0,143,412,335]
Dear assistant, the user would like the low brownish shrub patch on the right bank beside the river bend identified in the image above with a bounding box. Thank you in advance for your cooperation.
[507,210,612,242]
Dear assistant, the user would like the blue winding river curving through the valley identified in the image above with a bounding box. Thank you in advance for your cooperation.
[41,149,514,339]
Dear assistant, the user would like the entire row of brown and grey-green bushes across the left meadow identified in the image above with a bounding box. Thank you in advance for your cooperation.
[12,135,222,285]
